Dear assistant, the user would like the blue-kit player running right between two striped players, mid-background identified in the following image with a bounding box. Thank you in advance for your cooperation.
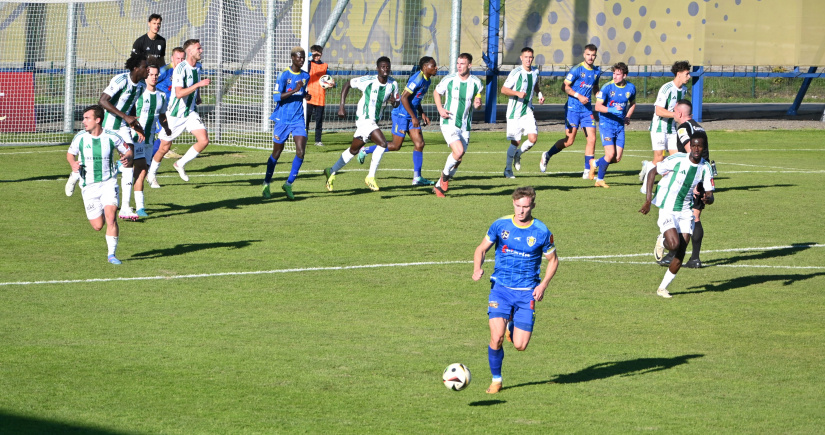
[358,56,438,186]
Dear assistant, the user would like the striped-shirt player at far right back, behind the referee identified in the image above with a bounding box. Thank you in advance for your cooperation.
[639,60,690,186]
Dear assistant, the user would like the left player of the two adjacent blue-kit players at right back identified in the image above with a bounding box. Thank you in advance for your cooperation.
[539,44,602,180]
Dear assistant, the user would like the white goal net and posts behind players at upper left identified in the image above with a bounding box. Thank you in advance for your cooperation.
[0,0,309,148]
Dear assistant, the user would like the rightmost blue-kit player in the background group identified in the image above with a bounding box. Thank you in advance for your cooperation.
[589,62,636,188]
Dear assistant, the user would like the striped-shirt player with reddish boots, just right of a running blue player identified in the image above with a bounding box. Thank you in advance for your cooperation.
[433,53,484,198]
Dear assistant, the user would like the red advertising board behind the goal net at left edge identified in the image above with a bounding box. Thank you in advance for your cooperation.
[0,72,35,133]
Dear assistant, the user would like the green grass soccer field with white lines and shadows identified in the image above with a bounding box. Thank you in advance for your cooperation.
[0,131,825,434]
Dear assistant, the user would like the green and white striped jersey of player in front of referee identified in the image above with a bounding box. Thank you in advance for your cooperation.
[653,153,714,211]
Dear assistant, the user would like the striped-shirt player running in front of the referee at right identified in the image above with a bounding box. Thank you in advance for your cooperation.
[639,130,714,298]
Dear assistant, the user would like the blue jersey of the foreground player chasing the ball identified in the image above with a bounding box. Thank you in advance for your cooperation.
[487,215,556,290]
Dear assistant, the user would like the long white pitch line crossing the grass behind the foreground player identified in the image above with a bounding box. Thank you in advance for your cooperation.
[0,244,825,287]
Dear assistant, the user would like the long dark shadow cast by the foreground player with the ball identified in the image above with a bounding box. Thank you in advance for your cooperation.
[502,354,705,390]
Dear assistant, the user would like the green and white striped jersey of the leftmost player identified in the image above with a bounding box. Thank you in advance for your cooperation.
[69,130,129,187]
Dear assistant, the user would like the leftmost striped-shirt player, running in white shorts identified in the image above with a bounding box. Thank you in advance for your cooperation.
[66,106,132,264]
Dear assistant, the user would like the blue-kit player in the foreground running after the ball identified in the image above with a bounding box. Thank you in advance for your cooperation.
[473,187,559,394]
